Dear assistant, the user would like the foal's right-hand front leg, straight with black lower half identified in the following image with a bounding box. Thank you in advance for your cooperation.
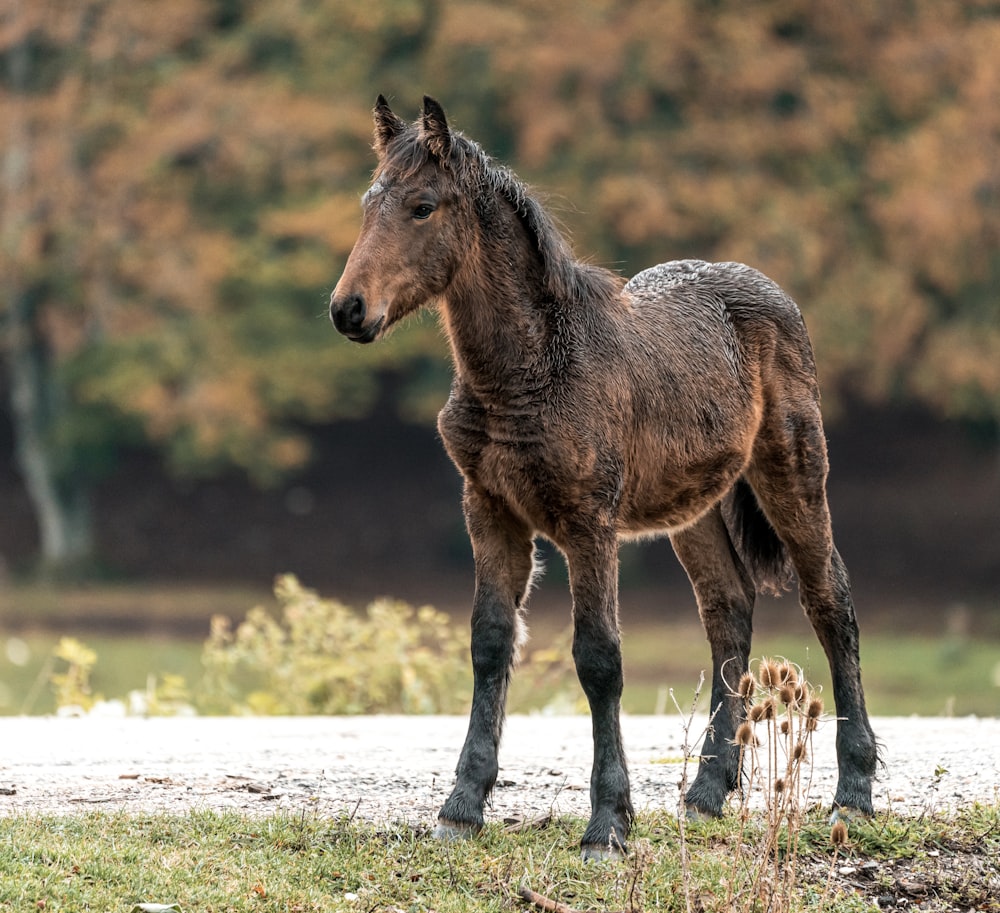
[567,531,634,859]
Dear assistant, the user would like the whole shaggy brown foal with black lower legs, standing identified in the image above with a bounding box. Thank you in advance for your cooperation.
[330,97,876,856]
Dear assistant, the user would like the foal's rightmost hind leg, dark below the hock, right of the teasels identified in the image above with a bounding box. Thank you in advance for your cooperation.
[747,407,878,815]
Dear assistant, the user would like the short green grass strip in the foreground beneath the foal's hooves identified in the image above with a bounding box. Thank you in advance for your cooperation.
[0,806,1000,913]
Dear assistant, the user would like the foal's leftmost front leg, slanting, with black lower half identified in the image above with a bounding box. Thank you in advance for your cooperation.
[434,488,534,840]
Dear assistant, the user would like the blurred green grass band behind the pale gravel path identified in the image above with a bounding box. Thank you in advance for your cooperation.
[0,620,1000,716]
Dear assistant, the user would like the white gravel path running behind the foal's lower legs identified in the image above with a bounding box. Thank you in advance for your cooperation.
[0,716,1000,825]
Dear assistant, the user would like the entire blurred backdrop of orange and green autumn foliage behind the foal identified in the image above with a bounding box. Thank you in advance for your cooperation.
[0,0,1000,564]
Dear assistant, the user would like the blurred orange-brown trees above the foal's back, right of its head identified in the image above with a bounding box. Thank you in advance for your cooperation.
[424,0,1000,428]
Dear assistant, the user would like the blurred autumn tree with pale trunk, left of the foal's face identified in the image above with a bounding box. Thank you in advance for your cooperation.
[0,0,446,574]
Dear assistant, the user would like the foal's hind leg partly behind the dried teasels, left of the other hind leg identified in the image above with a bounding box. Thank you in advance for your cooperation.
[671,507,756,817]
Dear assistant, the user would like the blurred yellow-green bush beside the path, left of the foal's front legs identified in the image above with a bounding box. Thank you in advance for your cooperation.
[198,575,472,715]
